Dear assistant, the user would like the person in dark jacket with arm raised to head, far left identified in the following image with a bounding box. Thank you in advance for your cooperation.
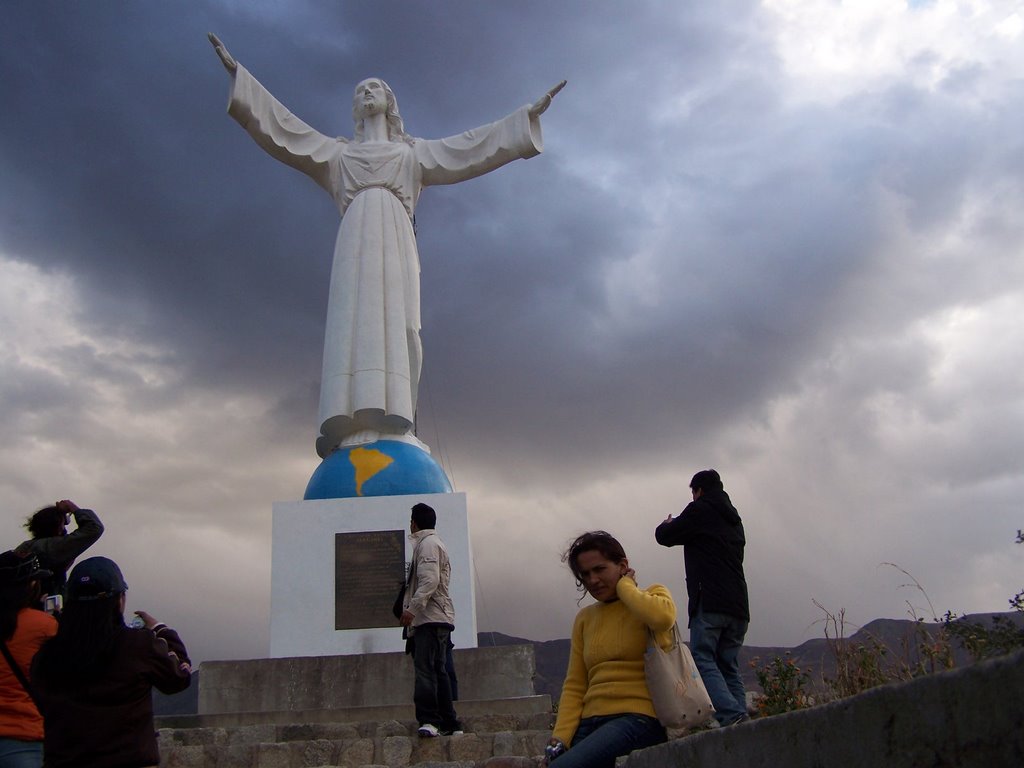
[16,499,103,606]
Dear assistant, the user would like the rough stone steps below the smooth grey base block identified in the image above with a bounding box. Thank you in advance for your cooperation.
[158,696,553,768]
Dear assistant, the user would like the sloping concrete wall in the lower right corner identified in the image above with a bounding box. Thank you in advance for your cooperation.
[626,651,1024,768]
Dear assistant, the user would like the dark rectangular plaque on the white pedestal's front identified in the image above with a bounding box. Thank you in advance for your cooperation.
[334,530,406,630]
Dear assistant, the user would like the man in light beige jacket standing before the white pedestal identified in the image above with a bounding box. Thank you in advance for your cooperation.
[400,504,462,737]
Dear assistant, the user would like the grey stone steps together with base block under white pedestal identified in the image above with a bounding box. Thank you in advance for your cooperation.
[156,646,554,768]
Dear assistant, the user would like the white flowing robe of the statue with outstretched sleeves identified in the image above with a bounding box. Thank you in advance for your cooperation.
[228,65,543,456]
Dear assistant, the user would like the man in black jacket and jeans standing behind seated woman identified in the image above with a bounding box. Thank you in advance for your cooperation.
[654,469,751,725]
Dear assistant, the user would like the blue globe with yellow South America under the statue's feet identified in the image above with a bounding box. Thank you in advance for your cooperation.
[303,440,452,501]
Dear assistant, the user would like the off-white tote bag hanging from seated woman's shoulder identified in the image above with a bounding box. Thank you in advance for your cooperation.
[643,624,715,728]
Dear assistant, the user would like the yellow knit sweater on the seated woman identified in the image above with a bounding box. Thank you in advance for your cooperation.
[552,577,676,744]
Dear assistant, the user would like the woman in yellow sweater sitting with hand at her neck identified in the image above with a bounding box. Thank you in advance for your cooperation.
[548,530,676,768]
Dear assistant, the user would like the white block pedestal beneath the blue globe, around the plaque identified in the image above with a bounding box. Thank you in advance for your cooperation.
[270,494,476,658]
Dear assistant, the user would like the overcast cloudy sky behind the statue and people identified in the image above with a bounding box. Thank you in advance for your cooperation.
[0,0,1024,659]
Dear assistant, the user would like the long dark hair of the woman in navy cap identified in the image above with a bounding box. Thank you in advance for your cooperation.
[32,594,128,689]
